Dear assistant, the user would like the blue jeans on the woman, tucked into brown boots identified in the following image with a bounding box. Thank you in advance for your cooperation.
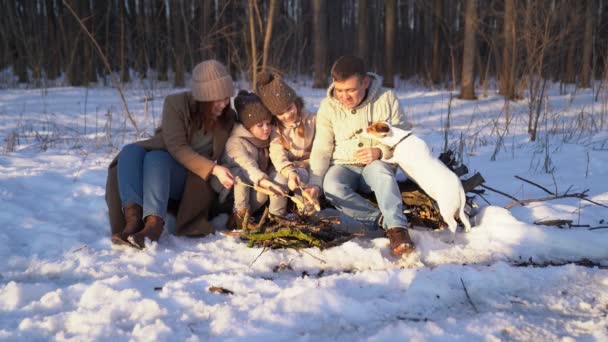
[117,144,188,220]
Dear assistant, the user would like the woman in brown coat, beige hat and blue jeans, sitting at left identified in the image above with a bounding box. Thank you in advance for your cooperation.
[106,60,235,248]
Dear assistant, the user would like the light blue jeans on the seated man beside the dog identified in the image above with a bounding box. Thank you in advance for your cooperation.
[323,160,407,229]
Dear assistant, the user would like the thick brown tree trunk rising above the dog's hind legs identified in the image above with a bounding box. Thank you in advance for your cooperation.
[460,0,477,100]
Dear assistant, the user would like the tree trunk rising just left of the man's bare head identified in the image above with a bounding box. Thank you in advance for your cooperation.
[312,0,327,88]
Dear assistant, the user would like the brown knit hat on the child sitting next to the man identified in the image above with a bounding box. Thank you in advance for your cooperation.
[255,72,297,115]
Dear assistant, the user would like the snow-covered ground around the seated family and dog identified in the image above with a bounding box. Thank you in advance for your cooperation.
[0,79,608,341]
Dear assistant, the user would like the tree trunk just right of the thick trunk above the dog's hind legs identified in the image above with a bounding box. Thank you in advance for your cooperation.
[500,0,516,100]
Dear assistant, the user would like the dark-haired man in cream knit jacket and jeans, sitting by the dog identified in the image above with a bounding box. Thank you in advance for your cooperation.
[307,56,415,255]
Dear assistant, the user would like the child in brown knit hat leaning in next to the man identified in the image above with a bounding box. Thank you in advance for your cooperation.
[255,72,316,216]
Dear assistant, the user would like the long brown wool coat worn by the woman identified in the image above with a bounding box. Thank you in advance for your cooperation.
[106,91,236,236]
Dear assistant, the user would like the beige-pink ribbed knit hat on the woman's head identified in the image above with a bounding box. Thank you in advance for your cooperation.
[192,59,234,102]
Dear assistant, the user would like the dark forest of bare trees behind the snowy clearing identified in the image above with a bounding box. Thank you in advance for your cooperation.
[0,0,608,99]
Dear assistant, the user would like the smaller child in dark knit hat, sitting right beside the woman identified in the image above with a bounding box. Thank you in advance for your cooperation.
[222,91,286,229]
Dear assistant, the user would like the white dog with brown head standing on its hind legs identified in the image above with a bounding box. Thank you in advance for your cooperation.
[362,122,471,233]
